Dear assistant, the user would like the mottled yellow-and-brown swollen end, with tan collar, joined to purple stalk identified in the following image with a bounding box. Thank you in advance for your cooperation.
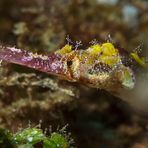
[53,42,135,92]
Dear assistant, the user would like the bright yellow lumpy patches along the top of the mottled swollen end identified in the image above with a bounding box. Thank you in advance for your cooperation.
[56,42,121,67]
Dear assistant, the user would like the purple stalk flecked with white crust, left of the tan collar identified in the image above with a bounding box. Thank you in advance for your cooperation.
[0,47,67,77]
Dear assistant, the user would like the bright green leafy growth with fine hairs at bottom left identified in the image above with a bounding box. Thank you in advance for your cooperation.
[0,126,73,148]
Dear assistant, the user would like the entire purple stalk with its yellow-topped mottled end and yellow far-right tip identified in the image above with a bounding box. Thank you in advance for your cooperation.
[0,42,148,92]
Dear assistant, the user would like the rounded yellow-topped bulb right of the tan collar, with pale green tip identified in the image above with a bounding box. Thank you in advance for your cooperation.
[80,42,135,92]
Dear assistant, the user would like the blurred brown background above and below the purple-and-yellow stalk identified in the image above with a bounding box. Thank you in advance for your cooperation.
[0,0,148,148]
